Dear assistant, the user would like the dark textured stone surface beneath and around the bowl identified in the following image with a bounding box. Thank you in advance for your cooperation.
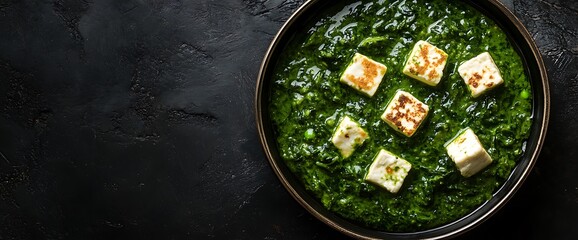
[0,0,578,239]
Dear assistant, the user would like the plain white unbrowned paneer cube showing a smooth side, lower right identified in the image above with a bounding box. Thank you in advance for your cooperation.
[446,128,492,177]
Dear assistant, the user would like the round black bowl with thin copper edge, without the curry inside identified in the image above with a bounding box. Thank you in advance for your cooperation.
[255,0,550,239]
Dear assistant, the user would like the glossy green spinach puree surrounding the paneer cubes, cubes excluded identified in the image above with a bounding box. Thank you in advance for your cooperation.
[270,0,532,232]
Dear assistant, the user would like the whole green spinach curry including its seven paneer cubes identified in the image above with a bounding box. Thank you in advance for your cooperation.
[270,0,532,232]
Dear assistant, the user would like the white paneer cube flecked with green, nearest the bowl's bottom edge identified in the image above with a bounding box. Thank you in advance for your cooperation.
[365,149,411,193]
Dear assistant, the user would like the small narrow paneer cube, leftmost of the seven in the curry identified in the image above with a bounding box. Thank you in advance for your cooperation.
[331,116,369,158]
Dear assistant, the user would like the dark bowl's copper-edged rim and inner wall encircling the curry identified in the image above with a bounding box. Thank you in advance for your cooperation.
[255,0,550,239]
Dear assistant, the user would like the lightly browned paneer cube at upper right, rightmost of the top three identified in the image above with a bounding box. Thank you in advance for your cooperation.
[458,52,504,97]
